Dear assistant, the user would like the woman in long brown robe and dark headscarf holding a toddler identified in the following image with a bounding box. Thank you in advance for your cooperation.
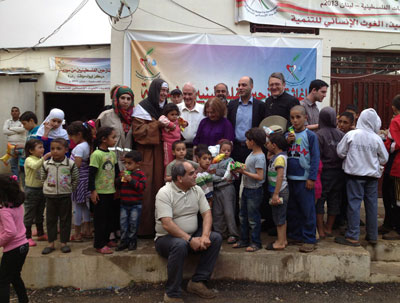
[132,79,168,236]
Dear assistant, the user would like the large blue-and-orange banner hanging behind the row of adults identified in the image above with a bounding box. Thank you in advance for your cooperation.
[124,32,322,103]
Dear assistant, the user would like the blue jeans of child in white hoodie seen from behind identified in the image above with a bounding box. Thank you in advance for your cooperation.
[346,176,378,241]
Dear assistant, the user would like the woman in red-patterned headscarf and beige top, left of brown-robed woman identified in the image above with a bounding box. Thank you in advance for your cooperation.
[96,86,134,171]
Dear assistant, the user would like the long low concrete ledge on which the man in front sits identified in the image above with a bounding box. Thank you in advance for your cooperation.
[18,238,370,289]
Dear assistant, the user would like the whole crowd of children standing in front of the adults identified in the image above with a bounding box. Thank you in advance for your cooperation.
[0,95,400,298]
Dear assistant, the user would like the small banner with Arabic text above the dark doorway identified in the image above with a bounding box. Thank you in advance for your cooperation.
[55,57,111,90]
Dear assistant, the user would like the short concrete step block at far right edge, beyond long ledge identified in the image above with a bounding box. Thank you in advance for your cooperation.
[366,237,400,262]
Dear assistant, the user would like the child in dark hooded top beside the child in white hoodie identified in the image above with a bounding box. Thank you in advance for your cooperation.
[316,107,344,239]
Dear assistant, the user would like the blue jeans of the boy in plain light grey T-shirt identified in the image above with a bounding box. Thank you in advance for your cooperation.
[239,187,263,247]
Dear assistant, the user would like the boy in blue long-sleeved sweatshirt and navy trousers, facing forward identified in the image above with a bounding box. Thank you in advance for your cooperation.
[287,105,319,252]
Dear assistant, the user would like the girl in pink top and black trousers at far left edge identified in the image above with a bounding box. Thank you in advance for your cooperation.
[0,175,29,302]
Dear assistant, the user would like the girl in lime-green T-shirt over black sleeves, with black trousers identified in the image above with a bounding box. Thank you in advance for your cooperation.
[89,127,119,254]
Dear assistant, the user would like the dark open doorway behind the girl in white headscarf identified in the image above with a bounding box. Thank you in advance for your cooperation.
[43,93,105,124]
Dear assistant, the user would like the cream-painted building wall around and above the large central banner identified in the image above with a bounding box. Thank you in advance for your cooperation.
[111,0,400,106]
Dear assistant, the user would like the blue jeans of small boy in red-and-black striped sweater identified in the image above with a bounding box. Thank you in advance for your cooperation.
[120,204,142,243]
